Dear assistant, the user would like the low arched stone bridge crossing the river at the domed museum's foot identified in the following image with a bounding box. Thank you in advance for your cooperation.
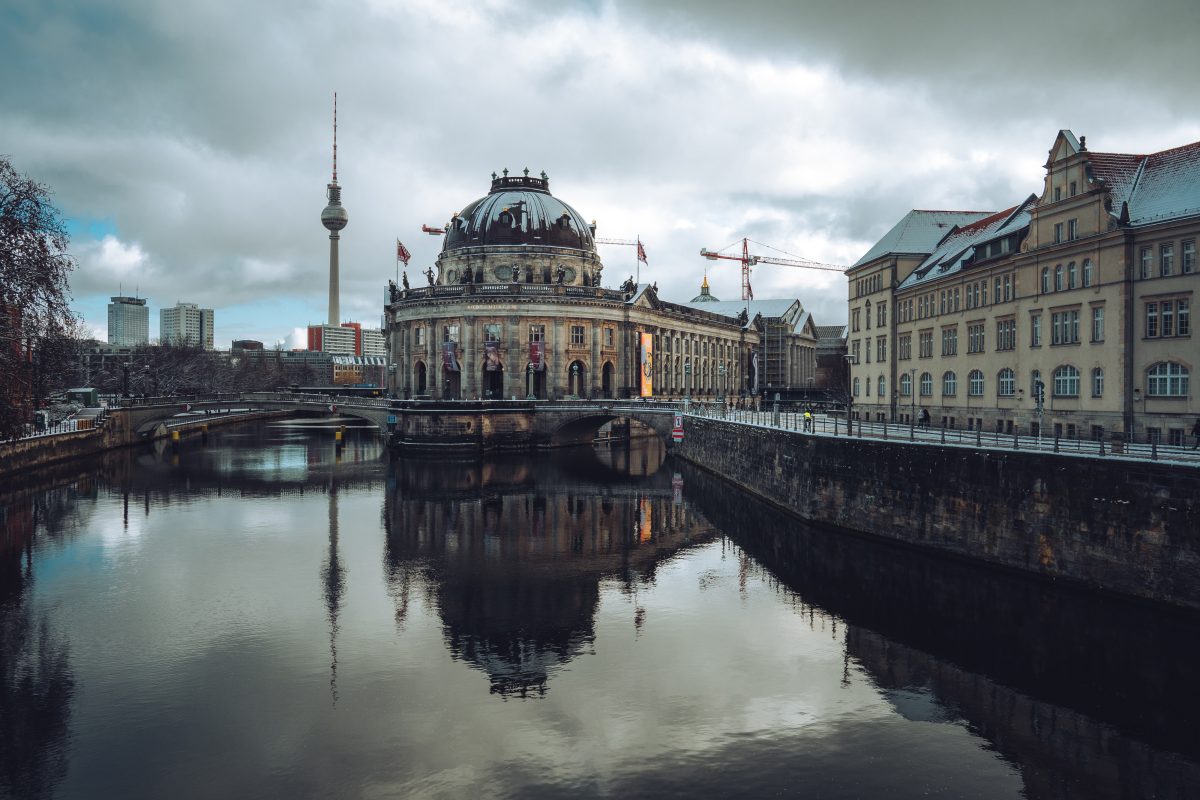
[108,392,680,451]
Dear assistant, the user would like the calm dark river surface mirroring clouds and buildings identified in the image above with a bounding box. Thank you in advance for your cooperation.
[0,426,1200,799]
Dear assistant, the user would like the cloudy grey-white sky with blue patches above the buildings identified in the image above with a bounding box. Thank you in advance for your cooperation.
[0,0,1200,348]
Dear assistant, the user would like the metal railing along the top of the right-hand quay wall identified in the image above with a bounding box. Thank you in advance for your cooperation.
[688,405,1200,468]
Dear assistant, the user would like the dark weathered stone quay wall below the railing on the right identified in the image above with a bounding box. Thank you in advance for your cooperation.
[673,417,1200,610]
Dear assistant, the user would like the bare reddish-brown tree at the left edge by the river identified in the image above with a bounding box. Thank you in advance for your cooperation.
[0,156,77,438]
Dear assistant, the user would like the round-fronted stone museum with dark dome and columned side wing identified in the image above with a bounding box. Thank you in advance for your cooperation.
[385,170,823,399]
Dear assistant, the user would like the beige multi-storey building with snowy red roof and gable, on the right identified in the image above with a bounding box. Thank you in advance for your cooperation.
[848,131,1200,444]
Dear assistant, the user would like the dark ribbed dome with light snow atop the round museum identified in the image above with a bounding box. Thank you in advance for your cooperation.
[442,170,595,251]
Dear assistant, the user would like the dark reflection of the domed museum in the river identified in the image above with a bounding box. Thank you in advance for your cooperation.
[384,440,714,697]
